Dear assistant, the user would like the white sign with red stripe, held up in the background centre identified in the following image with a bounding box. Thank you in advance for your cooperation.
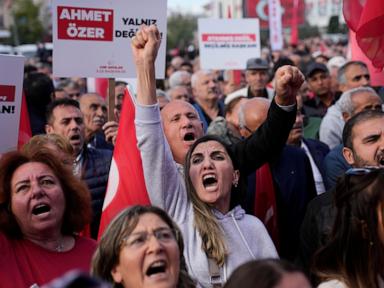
[198,19,260,70]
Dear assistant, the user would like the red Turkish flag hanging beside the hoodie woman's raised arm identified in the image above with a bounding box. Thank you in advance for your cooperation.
[98,89,150,238]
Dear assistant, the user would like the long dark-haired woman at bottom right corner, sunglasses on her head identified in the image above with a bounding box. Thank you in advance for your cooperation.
[314,168,384,288]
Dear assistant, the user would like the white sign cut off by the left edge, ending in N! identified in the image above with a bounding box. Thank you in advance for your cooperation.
[0,55,24,154]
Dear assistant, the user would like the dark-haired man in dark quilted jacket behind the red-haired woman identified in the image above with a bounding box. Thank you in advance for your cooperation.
[45,98,112,239]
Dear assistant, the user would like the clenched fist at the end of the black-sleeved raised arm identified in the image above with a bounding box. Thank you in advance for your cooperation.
[275,65,305,106]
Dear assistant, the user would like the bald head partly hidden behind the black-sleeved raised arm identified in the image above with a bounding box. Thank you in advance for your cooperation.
[239,97,271,137]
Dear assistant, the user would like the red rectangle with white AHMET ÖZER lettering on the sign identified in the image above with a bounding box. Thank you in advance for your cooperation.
[57,6,113,41]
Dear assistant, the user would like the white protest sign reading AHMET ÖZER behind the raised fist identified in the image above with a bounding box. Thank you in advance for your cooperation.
[52,0,167,79]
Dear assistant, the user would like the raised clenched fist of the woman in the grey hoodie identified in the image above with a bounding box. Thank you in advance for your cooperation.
[131,25,161,65]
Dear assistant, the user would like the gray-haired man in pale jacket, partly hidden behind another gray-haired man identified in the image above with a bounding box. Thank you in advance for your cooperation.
[319,61,370,149]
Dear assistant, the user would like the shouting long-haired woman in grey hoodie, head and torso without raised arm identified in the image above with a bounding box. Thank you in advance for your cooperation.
[179,135,278,287]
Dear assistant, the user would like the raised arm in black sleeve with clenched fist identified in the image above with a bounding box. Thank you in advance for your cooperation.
[234,66,304,176]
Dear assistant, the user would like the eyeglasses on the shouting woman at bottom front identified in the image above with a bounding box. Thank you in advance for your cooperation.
[123,228,176,248]
